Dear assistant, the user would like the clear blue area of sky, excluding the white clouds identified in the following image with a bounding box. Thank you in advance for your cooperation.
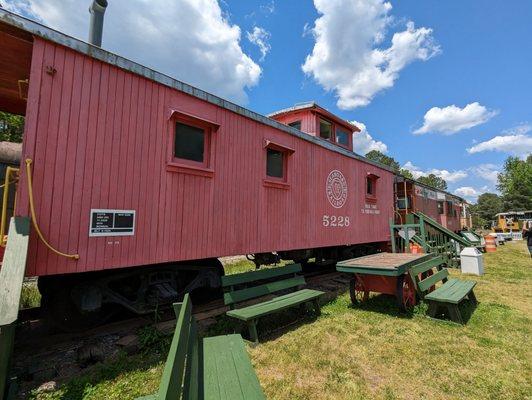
[225,0,532,198]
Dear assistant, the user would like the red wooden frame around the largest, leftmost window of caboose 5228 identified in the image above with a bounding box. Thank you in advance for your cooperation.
[166,110,220,177]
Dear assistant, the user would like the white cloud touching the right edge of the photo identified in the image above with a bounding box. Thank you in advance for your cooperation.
[467,124,532,156]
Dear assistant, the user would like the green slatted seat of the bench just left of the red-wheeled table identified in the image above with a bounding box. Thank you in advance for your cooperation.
[227,289,324,321]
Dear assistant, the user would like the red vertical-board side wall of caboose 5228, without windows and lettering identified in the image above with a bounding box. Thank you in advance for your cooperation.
[17,38,393,275]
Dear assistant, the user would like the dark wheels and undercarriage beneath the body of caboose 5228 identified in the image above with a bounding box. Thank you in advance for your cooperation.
[38,243,387,331]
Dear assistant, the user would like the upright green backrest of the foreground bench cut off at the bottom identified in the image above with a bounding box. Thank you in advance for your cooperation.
[157,294,199,400]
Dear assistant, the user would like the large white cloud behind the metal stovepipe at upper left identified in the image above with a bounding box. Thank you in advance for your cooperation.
[2,0,261,102]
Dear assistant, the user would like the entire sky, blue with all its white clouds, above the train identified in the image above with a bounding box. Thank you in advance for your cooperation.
[3,0,532,200]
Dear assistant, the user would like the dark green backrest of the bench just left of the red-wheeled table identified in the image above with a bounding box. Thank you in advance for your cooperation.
[222,264,305,308]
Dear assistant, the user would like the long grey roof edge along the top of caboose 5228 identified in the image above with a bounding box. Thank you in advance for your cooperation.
[0,8,393,172]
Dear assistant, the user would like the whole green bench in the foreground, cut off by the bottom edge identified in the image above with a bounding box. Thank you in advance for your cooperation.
[137,294,266,400]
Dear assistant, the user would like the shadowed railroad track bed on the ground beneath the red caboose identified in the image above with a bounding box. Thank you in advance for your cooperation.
[14,270,348,395]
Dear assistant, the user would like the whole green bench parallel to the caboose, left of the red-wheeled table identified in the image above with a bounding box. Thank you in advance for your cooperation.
[222,264,324,343]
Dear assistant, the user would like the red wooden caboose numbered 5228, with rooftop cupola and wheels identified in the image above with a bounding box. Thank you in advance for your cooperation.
[0,10,394,319]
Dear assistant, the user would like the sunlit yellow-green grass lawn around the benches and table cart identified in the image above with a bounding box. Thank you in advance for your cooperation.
[33,242,532,400]
